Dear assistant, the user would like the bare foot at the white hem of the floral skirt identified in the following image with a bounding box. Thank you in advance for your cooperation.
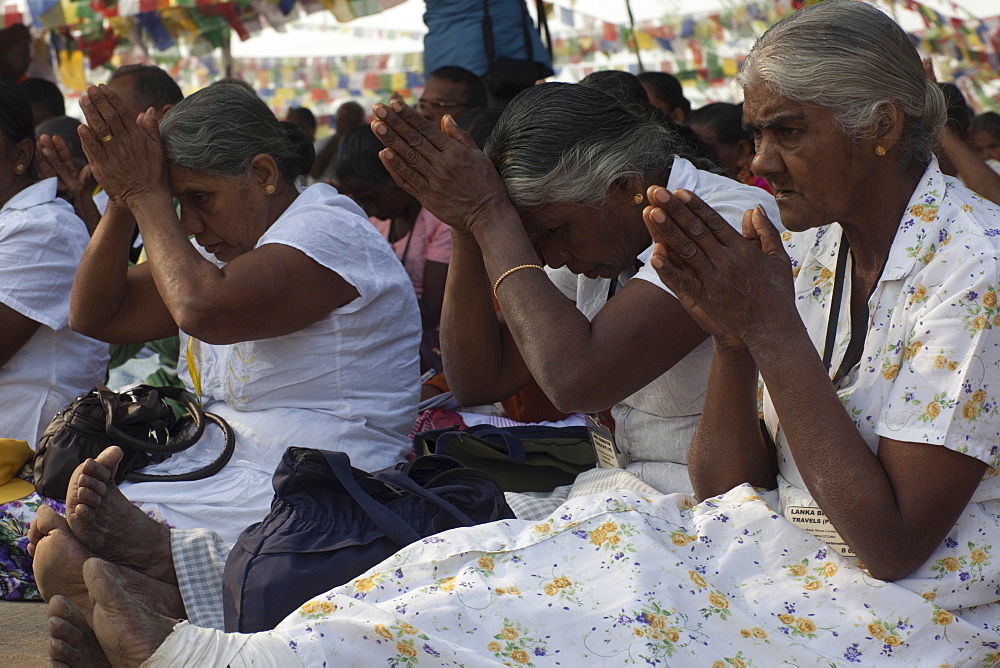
[83,559,177,666]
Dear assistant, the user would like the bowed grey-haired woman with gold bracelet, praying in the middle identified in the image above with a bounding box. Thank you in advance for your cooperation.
[422,83,777,500]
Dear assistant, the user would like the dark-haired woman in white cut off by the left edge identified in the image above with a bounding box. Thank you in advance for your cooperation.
[0,80,108,448]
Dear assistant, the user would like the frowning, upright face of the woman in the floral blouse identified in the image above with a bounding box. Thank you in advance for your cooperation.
[743,82,876,231]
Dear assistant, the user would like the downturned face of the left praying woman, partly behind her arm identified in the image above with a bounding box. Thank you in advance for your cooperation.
[170,166,270,262]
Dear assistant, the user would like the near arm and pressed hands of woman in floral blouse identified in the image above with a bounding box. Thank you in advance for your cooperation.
[645,188,986,580]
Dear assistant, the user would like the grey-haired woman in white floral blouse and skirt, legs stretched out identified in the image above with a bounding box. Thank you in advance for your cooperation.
[35,0,1000,667]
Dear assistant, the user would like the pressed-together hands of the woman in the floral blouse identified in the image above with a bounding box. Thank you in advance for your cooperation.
[642,186,798,347]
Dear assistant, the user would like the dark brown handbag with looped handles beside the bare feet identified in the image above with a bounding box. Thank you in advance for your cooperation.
[33,385,236,500]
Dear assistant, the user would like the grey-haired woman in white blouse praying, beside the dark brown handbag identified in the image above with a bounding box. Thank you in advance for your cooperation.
[69,84,420,541]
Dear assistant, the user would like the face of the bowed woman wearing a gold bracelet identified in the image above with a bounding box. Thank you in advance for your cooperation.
[521,193,650,278]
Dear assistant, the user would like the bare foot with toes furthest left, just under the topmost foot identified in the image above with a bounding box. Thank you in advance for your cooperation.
[29,506,186,624]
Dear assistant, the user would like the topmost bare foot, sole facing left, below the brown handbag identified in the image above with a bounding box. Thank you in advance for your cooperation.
[66,446,177,584]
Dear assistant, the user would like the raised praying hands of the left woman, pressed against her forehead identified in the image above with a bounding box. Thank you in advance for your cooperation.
[78,84,170,203]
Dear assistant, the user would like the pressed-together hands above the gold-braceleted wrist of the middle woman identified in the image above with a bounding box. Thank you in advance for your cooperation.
[372,100,512,231]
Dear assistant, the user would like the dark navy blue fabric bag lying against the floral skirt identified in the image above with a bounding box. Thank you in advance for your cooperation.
[222,448,514,633]
